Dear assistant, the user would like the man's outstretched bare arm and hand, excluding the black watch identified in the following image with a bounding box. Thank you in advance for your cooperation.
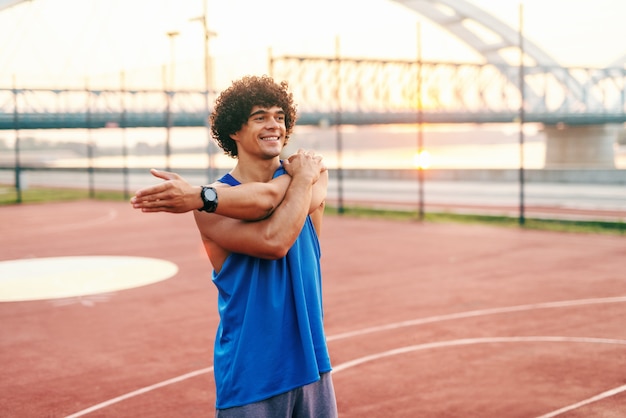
[130,169,290,221]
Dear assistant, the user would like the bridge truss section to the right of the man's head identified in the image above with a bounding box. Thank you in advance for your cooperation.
[270,56,626,125]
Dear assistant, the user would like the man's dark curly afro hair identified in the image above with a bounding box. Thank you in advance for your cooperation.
[210,76,296,158]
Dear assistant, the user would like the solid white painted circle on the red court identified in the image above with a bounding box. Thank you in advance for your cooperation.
[0,256,178,302]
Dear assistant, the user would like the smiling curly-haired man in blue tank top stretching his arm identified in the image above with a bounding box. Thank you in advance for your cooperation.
[132,77,337,418]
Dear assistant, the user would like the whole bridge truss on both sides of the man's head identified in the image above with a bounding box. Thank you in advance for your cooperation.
[0,56,626,129]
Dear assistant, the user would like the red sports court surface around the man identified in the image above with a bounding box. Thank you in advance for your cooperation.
[0,201,626,418]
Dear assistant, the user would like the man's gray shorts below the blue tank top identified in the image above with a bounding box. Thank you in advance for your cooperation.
[215,373,337,418]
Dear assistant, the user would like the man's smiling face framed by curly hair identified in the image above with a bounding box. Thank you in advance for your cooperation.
[231,106,287,158]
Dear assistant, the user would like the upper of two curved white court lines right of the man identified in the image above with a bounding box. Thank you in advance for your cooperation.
[327,296,626,341]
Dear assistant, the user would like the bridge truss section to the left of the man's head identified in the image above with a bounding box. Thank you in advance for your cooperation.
[0,88,207,129]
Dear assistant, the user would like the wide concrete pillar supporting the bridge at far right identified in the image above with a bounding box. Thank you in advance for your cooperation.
[544,125,622,168]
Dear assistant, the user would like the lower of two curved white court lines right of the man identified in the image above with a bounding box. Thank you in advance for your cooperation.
[333,336,626,373]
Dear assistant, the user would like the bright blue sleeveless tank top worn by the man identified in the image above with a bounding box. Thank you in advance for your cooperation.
[213,167,331,409]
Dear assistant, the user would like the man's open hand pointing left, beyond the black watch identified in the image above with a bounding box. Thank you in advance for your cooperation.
[130,169,202,213]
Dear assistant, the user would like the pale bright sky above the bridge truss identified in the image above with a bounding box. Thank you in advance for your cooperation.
[0,0,626,89]
